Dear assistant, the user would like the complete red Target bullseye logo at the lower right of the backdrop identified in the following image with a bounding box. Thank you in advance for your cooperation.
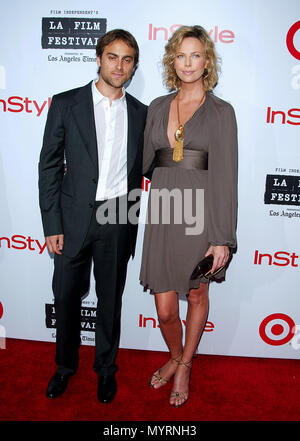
[259,313,296,346]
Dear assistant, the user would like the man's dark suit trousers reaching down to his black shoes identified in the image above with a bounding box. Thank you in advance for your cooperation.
[53,198,130,375]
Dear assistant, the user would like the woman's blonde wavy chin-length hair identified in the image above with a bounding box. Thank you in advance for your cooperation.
[162,26,220,91]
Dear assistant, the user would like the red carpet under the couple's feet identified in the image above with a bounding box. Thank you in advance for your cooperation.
[0,339,300,421]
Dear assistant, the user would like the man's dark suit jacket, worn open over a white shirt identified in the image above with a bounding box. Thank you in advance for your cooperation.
[39,83,147,257]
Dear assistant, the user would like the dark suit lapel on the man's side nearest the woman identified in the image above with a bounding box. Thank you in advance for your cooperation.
[126,93,139,176]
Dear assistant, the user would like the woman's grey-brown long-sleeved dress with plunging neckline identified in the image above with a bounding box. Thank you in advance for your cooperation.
[140,93,237,294]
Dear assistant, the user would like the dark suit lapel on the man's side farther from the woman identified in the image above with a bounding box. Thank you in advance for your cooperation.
[72,83,98,173]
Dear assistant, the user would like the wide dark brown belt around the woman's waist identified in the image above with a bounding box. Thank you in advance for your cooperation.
[155,147,208,170]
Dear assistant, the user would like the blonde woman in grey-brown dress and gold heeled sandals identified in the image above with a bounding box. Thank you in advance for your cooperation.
[140,26,237,407]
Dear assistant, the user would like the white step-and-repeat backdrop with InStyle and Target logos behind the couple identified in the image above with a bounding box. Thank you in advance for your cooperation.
[0,0,300,358]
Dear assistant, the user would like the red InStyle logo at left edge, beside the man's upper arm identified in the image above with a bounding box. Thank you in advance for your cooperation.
[0,95,51,116]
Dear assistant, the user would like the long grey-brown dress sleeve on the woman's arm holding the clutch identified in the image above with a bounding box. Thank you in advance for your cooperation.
[208,103,238,248]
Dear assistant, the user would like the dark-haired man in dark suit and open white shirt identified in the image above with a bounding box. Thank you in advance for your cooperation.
[39,29,147,403]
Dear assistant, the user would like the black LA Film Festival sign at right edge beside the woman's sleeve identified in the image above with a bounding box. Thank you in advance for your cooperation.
[264,175,300,206]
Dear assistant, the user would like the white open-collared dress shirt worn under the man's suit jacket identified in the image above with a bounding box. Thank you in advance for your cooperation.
[92,81,128,201]
